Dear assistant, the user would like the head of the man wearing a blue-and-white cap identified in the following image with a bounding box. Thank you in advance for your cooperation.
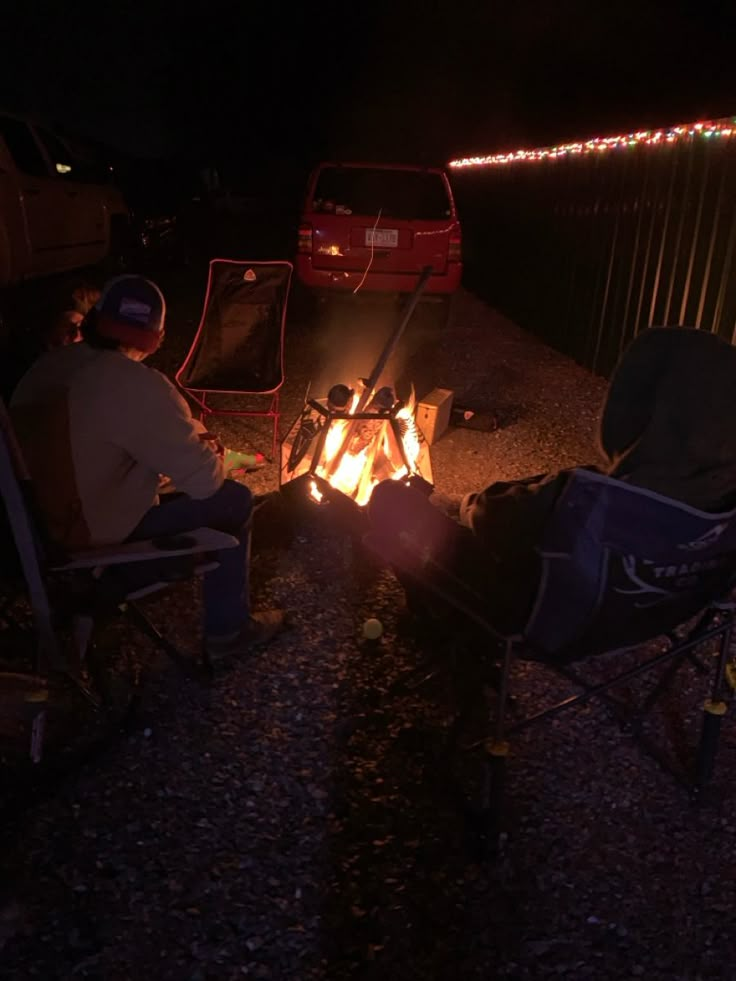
[81,275,166,360]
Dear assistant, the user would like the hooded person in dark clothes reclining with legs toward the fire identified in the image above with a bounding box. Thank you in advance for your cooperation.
[369,327,736,632]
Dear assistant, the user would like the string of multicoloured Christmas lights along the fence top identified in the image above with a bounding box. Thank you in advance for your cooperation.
[448,116,736,169]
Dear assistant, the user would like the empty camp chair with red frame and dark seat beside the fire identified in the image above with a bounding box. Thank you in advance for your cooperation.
[176,259,292,457]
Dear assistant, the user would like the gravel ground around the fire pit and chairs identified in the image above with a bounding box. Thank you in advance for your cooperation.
[0,276,736,981]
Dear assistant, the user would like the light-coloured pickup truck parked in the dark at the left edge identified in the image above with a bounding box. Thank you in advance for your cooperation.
[0,113,129,287]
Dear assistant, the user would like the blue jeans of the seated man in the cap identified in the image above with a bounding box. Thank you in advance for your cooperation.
[128,480,253,636]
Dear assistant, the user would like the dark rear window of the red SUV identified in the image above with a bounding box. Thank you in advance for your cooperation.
[312,167,452,221]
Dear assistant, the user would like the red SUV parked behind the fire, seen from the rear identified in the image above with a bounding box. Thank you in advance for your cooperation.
[296,163,462,295]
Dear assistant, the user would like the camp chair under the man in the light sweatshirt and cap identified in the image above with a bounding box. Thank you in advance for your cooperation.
[0,401,238,762]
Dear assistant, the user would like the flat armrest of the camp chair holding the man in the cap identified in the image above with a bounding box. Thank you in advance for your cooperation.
[52,528,239,572]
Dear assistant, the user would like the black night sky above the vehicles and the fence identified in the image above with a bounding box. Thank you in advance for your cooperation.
[0,0,736,163]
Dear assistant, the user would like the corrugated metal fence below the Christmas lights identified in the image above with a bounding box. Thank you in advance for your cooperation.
[451,130,736,375]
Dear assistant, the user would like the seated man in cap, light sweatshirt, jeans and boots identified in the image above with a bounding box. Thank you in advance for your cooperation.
[11,276,283,660]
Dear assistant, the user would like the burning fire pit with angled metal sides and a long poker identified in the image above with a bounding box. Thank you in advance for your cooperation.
[281,269,432,509]
